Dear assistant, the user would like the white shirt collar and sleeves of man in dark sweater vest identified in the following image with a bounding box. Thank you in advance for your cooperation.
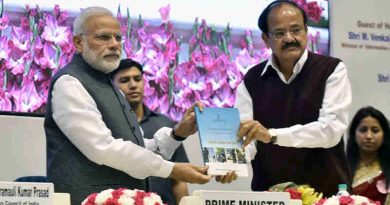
[235,50,352,159]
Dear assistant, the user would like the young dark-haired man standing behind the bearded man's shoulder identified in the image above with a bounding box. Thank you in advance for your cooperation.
[111,59,189,205]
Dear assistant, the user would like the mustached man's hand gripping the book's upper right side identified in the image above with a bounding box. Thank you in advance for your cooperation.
[238,120,271,147]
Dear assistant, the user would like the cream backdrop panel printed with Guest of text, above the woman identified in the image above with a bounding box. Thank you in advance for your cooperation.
[330,0,390,118]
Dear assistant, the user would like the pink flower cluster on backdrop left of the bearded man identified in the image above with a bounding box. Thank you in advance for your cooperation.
[0,6,75,112]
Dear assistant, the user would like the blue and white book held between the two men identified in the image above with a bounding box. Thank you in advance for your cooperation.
[195,107,248,177]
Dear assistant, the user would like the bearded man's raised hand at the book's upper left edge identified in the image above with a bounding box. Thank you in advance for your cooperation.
[173,102,203,138]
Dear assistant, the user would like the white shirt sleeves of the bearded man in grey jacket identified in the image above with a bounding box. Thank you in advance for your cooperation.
[51,75,180,179]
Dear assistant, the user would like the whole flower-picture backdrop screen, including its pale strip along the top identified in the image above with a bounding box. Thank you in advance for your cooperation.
[0,0,329,120]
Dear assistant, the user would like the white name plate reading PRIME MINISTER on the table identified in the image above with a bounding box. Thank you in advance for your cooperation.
[179,190,302,205]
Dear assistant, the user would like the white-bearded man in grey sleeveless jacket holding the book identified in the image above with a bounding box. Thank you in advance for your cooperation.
[45,7,225,204]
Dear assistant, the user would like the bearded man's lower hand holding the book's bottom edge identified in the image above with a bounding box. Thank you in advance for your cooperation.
[170,163,213,184]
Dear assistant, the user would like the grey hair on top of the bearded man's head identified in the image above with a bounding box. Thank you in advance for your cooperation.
[73,6,115,35]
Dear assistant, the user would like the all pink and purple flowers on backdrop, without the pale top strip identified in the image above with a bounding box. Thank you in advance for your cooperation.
[0,0,329,120]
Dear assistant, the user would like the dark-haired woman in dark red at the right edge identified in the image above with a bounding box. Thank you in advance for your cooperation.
[347,106,390,205]
